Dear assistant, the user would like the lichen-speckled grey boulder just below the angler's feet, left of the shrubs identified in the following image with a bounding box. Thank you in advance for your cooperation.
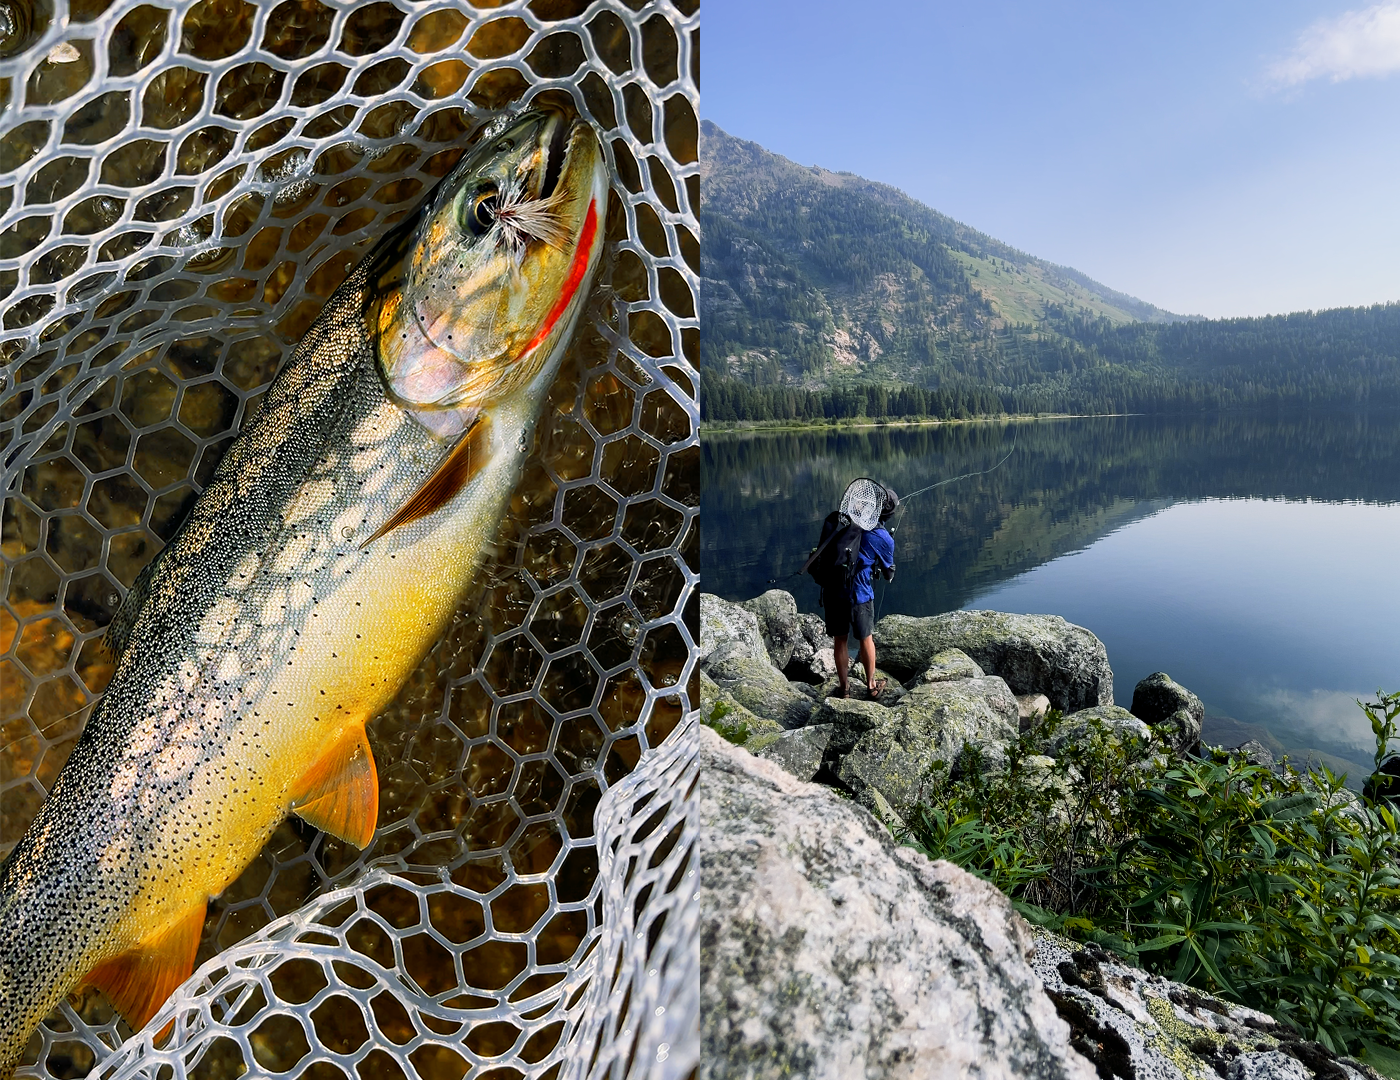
[813,675,1019,817]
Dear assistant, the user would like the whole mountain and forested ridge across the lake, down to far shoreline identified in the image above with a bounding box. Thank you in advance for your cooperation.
[700,122,1400,420]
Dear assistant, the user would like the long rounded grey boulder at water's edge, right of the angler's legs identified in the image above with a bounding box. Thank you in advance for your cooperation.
[875,611,1113,713]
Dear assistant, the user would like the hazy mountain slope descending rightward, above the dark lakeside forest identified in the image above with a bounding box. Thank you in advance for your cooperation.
[700,120,1182,385]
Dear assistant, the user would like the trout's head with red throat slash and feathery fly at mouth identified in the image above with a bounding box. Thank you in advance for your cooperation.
[375,108,609,434]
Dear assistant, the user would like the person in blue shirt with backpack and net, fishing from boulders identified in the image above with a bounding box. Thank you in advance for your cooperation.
[802,478,899,699]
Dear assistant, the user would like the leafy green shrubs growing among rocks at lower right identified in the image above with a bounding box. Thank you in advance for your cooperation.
[903,693,1400,1063]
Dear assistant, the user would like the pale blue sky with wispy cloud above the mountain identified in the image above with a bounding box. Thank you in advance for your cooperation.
[701,0,1400,317]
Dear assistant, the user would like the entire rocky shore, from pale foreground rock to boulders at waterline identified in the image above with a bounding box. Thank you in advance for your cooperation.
[699,590,1379,1080]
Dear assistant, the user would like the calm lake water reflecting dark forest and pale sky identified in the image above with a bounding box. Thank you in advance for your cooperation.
[701,412,1400,783]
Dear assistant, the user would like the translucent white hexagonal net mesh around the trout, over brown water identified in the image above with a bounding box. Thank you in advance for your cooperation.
[0,0,699,1080]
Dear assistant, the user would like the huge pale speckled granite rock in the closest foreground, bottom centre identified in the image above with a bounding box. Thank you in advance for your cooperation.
[699,728,1095,1080]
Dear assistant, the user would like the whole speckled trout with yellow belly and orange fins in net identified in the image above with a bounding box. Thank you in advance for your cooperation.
[0,111,608,1074]
